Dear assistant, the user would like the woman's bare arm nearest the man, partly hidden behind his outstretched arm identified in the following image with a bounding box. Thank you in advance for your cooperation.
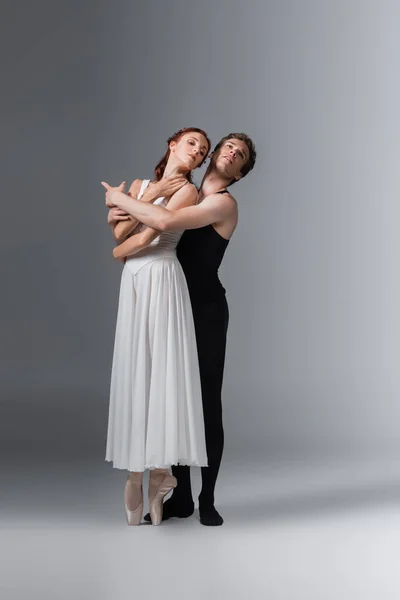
[113,185,197,259]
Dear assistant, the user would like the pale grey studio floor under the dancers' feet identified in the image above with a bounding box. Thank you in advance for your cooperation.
[0,459,400,600]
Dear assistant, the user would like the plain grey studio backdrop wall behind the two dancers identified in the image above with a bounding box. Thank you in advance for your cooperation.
[0,0,400,461]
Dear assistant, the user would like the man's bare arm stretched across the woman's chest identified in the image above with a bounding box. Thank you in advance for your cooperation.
[110,191,237,231]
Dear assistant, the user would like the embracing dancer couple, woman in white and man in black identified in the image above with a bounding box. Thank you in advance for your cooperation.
[102,127,256,526]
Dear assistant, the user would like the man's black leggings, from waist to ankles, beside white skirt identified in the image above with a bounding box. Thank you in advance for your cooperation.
[172,295,229,505]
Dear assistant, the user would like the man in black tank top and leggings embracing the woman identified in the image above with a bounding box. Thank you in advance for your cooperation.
[104,133,256,526]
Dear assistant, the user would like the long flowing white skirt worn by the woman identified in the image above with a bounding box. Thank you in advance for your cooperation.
[106,253,207,471]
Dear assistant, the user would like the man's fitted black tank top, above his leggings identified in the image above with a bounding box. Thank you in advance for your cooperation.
[177,190,229,302]
